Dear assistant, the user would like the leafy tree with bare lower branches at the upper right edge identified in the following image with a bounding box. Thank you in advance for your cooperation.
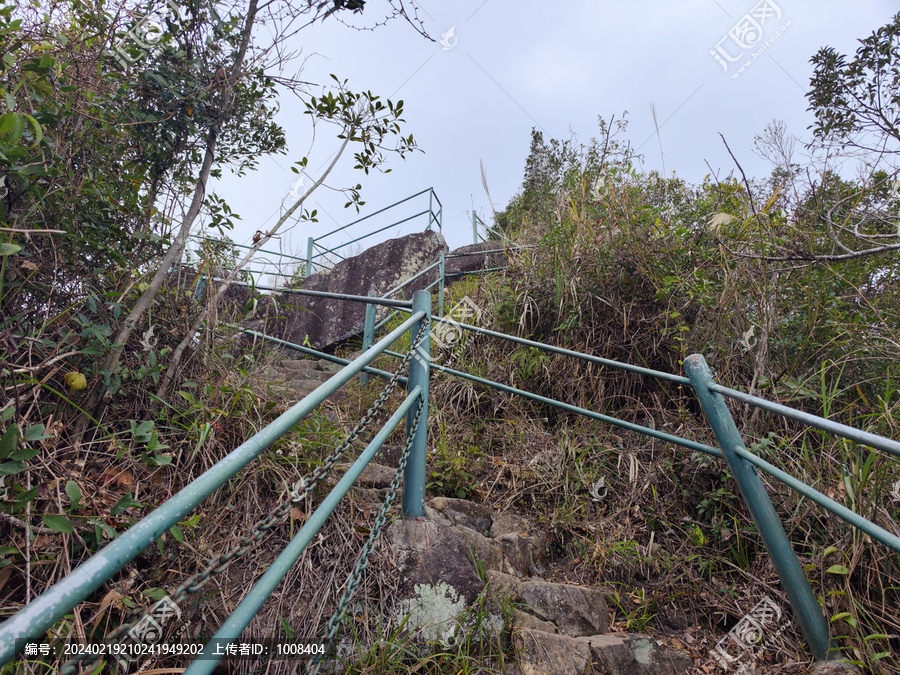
[712,14,900,264]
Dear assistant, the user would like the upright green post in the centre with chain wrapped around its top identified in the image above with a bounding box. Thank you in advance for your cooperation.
[403,291,431,518]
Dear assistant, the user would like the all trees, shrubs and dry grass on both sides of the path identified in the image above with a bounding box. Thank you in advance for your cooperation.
[0,5,900,673]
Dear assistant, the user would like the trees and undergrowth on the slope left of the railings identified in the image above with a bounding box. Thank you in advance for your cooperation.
[0,0,427,672]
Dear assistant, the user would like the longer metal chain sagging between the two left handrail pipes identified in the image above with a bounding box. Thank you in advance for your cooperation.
[59,315,430,675]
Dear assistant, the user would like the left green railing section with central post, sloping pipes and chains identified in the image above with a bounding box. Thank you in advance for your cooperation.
[0,291,431,675]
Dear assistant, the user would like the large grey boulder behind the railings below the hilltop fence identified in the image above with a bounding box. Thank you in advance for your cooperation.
[245,231,447,349]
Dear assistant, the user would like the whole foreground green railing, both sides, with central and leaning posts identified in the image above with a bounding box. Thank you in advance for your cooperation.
[0,266,900,675]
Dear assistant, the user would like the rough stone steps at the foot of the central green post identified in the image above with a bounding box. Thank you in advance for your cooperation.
[334,454,702,675]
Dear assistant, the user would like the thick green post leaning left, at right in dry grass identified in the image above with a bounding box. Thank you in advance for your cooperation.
[684,354,832,661]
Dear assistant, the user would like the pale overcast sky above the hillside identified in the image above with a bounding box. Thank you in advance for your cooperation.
[207,0,898,274]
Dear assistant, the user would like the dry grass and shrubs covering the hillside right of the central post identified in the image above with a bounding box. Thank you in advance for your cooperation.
[414,15,900,673]
